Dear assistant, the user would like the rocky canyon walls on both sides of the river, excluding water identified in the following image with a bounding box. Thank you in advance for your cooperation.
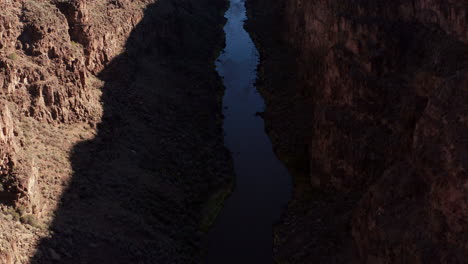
[0,0,468,264]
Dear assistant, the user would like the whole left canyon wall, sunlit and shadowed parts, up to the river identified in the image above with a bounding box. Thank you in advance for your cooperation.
[0,0,231,264]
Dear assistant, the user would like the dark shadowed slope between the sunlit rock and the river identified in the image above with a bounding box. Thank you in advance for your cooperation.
[31,0,231,264]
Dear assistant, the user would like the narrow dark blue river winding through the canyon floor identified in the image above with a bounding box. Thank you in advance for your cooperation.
[207,0,292,264]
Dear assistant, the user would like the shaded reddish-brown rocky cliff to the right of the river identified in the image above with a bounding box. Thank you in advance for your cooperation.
[249,0,468,263]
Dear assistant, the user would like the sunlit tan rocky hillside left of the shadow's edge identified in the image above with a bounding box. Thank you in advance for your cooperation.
[0,0,150,263]
